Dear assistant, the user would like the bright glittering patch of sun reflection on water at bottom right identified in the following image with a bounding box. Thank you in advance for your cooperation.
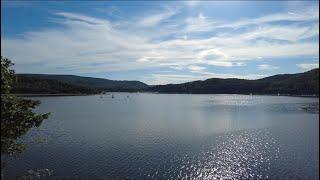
[178,129,279,179]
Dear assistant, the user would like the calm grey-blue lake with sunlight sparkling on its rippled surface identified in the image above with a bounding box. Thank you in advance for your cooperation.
[1,93,319,179]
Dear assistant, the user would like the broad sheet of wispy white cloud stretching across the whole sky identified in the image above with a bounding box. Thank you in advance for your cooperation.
[1,2,319,83]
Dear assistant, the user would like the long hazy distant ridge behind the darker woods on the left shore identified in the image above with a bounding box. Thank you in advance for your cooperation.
[17,74,148,90]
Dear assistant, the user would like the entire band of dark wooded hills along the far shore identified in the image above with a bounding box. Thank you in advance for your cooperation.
[12,66,319,95]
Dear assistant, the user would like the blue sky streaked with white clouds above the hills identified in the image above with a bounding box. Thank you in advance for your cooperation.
[1,1,319,85]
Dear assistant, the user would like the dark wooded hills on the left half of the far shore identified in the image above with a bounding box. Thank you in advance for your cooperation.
[13,74,148,94]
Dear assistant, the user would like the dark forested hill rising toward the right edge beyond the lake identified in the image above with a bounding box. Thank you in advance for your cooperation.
[148,68,319,95]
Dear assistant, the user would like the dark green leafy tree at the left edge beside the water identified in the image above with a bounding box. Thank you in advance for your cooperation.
[1,56,49,155]
